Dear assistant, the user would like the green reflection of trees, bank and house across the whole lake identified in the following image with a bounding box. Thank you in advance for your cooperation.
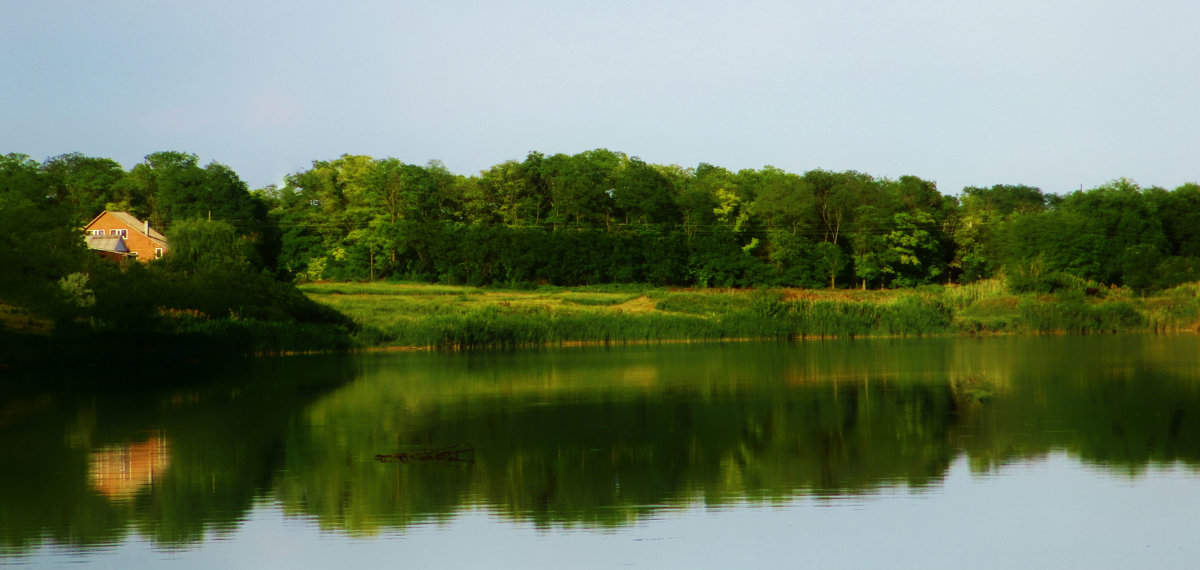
[0,336,1200,552]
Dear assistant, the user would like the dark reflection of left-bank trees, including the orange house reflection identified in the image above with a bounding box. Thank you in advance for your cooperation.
[0,358,354,552]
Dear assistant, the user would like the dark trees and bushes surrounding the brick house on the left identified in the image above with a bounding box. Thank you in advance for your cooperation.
[0,152,353,364]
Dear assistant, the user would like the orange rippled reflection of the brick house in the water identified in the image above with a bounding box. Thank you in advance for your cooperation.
[88,434,170,500]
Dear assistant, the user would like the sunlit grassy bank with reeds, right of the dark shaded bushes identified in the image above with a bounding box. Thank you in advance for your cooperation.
[300,280,1200,348]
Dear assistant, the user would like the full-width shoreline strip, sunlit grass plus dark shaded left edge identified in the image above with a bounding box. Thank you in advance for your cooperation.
[0,281,1200,373]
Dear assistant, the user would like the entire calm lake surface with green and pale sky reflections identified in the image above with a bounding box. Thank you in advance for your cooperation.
[0,336,1200,569]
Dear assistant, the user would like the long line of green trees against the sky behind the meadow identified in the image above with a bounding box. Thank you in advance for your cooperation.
[7,149,1200,296]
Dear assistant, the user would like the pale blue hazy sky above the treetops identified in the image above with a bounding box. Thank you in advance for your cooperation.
[0,0,1200,194]
